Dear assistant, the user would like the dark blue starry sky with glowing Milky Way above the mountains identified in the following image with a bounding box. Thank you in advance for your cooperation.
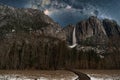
[0,0,120,26]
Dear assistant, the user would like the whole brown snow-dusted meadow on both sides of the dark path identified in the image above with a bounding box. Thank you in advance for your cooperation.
[0,70,120,80]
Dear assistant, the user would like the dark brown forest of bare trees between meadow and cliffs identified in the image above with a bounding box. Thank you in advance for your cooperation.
[0,33,120,70]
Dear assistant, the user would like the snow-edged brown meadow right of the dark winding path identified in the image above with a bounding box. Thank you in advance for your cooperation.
[79,70,120,80]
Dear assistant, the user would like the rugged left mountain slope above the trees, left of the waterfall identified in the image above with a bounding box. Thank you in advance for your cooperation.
[0,5,66,40]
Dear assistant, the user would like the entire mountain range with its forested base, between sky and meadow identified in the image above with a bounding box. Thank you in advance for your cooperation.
[0,6,120,70]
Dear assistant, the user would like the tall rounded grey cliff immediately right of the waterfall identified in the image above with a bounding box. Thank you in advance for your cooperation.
[76,17,106,42]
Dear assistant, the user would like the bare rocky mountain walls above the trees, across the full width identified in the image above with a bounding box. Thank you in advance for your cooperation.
[0,5,120,45]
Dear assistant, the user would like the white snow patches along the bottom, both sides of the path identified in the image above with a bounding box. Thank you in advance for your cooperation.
[0,72,120,80]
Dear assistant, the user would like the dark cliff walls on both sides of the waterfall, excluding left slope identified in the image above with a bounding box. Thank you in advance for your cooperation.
[64,16,120,44]
